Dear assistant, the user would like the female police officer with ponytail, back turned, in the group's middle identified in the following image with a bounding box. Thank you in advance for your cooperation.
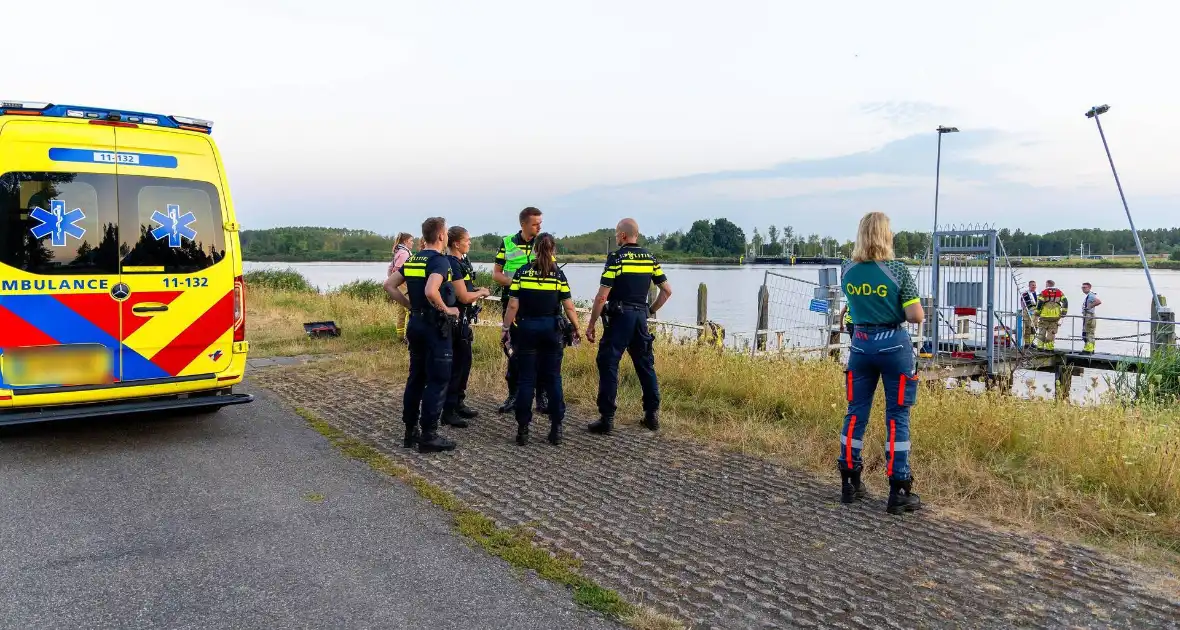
[502,234,582,446]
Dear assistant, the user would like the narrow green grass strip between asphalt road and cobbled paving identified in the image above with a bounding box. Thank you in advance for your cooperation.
[285,408,656,628]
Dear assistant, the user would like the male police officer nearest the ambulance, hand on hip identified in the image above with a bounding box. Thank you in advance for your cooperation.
[385,217,459,453]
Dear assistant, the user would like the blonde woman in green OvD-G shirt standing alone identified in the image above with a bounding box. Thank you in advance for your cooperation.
[838,212,924,514]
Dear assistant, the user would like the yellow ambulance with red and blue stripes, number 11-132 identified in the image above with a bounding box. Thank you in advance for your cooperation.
[0,100,253,425]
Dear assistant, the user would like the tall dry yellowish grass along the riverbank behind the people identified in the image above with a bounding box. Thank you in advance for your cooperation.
[248,274,1180,569]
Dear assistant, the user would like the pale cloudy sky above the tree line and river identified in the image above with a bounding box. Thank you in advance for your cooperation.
[0,0,1180,238]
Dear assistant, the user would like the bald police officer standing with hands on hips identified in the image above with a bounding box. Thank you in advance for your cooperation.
[586,218,671,434]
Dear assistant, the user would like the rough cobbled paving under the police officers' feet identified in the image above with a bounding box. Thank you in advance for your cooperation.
[254,369,1180,628]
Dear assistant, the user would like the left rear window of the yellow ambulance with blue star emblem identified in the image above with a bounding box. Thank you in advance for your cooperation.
[0,172,119,275]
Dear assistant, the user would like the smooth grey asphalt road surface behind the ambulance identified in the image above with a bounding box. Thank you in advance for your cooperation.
[0,384,611,630]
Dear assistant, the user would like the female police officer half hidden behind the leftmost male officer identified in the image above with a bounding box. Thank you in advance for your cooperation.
[443,225,492,428]
